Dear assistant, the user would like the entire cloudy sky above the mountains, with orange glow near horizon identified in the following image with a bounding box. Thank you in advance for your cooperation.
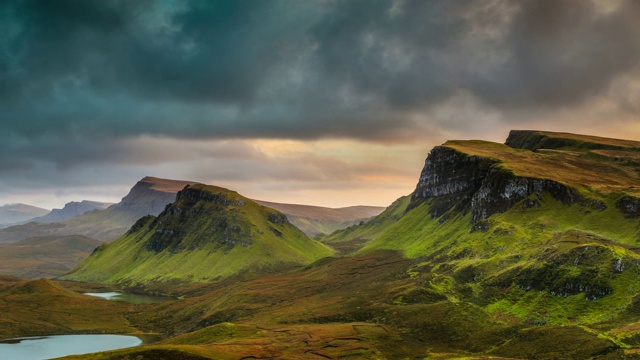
[0,0,640,208]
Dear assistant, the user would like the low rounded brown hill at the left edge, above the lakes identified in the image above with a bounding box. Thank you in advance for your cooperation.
[0,235,102,278]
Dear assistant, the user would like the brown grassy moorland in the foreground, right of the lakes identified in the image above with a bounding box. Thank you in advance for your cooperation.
[56,251,623,359]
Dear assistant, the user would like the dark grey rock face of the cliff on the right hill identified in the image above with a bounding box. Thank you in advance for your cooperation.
[409,146,606,223]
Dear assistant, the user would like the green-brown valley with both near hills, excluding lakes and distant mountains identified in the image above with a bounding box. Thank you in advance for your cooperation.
[0,131,640,360]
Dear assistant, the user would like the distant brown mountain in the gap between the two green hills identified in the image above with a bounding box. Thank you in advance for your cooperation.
[254,200,384,237]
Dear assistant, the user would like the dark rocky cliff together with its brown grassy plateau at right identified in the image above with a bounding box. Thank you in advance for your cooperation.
[409,131,640,223]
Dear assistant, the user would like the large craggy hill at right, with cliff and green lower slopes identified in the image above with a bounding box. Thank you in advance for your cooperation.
[326,132,640,324]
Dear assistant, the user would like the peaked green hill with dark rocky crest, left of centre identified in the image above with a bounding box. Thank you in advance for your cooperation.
[62,184,332,284]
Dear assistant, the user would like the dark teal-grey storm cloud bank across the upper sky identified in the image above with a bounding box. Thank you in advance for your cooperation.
[0,0,640,155]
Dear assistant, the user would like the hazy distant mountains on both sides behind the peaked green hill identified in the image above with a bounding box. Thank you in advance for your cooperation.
[0,176,384,243]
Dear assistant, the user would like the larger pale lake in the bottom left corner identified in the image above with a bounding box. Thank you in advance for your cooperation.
[0,335,142,360]
